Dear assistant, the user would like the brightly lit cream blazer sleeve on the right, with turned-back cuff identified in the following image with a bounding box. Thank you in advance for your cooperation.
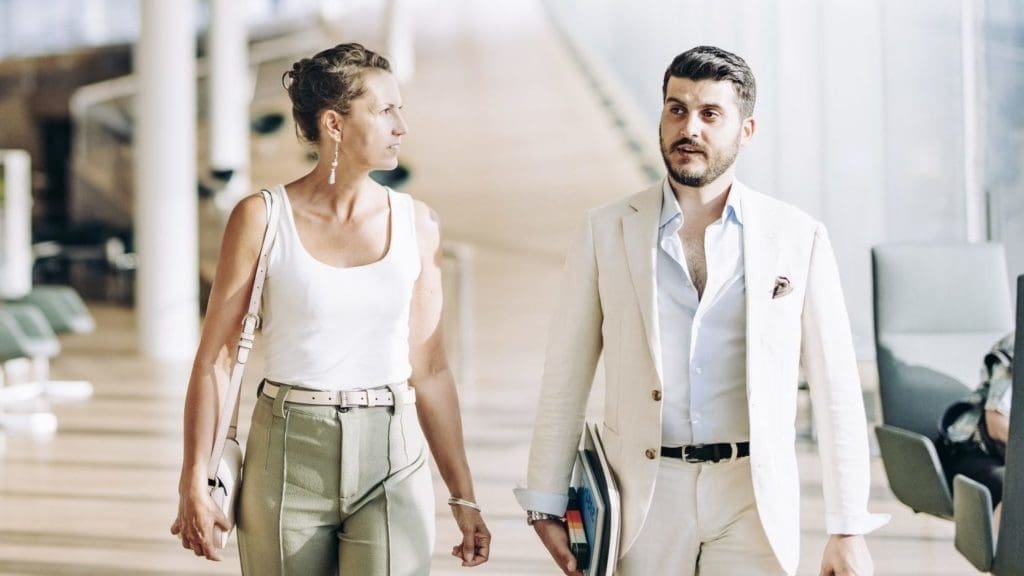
[801,224,889,534]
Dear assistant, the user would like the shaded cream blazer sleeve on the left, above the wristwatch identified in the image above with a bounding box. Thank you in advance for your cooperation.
[516,210,603,515]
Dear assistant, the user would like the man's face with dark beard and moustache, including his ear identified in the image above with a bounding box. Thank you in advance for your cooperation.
[660,77,754,188]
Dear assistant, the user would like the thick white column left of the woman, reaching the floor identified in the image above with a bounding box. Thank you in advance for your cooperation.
[134,0,199,360]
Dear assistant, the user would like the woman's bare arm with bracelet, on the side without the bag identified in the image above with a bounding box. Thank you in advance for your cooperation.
[410,202,490,566]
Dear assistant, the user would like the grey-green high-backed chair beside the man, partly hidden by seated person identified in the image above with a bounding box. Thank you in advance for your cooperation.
[871,239,1013,519]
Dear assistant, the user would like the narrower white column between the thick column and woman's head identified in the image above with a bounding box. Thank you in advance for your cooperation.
[207,0,252,205]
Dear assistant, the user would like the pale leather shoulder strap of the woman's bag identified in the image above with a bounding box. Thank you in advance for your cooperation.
[207,190,281,485]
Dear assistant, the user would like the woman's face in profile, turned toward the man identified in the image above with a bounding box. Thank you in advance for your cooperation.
[338,71,409,171]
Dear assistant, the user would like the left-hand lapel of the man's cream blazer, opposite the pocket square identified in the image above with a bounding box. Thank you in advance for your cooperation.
[623,181,663,381]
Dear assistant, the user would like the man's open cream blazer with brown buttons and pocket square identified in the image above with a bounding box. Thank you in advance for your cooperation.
[527,181,888,573]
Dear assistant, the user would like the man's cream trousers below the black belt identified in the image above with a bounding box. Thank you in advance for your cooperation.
[618,458,785,576]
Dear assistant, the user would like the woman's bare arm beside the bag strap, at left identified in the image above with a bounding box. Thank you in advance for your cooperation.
[171,195,267,560]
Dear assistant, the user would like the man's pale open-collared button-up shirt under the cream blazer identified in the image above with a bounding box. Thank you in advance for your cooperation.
[655,179,751,446]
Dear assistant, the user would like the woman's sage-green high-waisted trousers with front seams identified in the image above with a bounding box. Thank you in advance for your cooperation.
[238,385,434,576]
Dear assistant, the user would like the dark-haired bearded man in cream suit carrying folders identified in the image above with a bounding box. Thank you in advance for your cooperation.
[517,46,888,576]
